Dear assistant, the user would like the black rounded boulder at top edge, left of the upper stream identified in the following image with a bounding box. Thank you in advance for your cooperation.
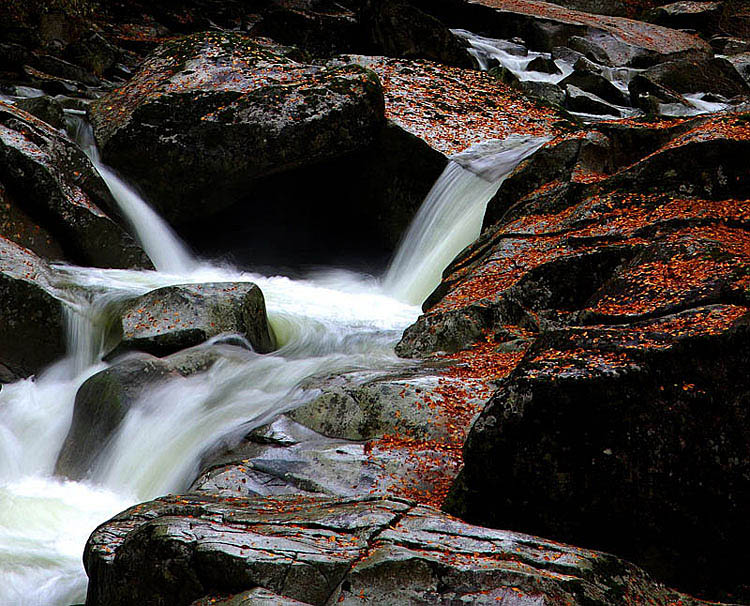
[359,0,472,68]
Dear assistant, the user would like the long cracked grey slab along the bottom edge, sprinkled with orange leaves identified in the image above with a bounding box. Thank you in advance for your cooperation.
[84,494,716,606]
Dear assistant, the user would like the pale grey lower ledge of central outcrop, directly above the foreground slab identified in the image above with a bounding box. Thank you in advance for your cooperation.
[190,416,455,504]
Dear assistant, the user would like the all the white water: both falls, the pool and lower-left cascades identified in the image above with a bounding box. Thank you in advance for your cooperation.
[0,117,542,606]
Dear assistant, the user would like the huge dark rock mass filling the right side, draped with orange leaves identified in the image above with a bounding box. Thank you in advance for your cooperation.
[397,114,750,597]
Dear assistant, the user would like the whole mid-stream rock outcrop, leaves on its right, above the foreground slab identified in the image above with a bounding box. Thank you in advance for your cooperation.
[191,357,494,505]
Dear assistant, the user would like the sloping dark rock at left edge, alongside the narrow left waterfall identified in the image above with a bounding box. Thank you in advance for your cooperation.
[0,100,151,267]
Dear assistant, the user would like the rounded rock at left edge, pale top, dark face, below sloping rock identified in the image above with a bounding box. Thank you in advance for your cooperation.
[0,236,65,381]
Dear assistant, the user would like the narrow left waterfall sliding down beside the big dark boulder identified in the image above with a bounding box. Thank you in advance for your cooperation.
[71,117,196,274]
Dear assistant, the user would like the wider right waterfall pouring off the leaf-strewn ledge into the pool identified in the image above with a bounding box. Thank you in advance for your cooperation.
[383,136,548,305]
